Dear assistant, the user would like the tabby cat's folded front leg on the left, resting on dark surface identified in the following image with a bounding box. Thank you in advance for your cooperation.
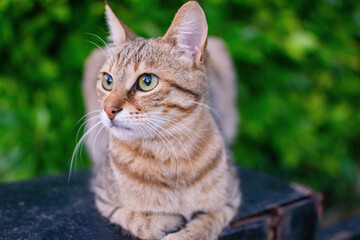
[96,198,185,239]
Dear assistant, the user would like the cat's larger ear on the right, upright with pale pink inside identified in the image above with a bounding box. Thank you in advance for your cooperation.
[163,1,208,65]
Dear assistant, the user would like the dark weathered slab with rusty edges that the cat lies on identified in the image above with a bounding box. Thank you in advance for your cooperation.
[0,169,320,240]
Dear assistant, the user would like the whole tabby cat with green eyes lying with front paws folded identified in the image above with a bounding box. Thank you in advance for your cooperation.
[83,1,241,240]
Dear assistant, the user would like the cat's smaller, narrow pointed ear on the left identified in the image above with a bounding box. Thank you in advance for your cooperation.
[105,2,136,45]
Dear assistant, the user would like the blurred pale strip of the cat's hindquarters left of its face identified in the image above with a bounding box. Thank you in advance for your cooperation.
[82,49,108,167]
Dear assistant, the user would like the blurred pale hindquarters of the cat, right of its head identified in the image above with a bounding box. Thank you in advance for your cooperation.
[207,37,239,144]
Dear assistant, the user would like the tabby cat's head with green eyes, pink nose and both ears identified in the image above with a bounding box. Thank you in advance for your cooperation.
[96,1,208,140]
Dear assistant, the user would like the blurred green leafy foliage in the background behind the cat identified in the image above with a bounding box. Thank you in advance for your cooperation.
[0,0,360,225]
